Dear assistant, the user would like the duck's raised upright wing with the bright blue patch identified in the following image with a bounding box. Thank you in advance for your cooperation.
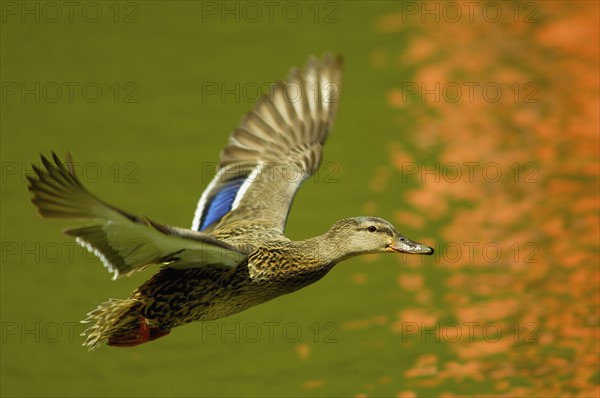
[192,54,342,233]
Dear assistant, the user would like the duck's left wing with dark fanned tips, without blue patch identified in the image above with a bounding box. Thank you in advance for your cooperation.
[27,153,246,279]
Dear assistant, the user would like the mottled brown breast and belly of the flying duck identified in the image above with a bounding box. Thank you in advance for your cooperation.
[113,236,335,345]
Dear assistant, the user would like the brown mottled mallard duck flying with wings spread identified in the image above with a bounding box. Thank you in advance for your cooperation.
[28,54,433,350]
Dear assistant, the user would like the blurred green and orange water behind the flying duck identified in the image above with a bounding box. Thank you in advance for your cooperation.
[0,1,600,397]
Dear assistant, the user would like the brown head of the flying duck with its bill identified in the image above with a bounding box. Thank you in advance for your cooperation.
[329,217,433,257]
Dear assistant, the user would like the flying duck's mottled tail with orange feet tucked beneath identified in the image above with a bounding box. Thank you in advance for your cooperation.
[81,298,170,351]
